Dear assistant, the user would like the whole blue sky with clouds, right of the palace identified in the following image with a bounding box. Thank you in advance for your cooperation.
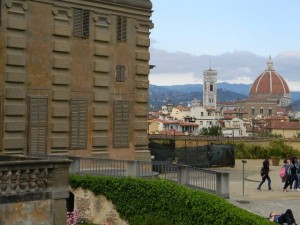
[149,0,300,91]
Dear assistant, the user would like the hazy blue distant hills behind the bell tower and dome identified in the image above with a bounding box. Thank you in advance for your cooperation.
[149,82,300,110]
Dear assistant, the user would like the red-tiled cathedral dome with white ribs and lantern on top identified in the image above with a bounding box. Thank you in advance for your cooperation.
[249,56,290,98]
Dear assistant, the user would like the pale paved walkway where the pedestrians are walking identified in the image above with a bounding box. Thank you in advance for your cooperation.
[216,159,300,223]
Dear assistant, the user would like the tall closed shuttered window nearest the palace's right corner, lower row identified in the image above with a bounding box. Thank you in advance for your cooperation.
[113,100,129,148]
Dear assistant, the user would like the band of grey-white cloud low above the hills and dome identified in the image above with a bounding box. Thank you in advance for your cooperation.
[149,48,300,91]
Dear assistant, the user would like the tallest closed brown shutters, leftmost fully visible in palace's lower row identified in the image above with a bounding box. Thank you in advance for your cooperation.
[28,96,48,155]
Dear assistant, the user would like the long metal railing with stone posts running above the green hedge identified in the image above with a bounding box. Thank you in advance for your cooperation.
[69,158,229,198]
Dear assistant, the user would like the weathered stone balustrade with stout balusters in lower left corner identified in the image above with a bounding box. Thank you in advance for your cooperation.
[0,156,71,225]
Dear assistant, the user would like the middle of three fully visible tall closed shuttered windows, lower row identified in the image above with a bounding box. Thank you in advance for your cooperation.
[69,99,88,149]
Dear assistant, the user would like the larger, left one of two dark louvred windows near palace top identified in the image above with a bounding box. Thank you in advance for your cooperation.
[73,9,90,38]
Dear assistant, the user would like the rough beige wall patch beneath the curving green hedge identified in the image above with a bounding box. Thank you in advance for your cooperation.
[71,188,128,225]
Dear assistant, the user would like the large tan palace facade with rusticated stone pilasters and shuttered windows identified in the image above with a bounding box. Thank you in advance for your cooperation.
[0,0,153,160]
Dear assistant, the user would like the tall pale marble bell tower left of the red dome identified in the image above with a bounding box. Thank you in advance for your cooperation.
[203,68,218,109]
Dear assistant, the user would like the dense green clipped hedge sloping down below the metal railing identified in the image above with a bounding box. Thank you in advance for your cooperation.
[69,175,270,225]
